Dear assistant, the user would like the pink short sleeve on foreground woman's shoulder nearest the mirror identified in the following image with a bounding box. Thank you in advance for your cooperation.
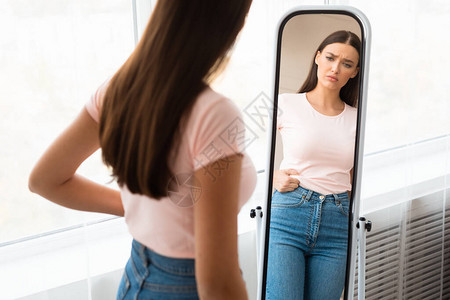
[189,98,246,170]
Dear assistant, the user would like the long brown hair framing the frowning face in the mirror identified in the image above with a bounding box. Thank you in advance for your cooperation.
[298,30,361,106]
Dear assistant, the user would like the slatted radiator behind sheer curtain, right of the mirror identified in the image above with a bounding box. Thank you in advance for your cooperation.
[354,190,450,300]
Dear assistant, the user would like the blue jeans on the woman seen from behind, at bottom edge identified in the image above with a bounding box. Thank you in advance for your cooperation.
[117,240,198,300]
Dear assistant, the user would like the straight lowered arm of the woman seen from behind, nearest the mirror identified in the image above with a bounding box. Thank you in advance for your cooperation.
[194,154,248,300]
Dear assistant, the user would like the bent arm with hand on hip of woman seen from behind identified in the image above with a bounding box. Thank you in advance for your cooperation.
[28,108,123,216]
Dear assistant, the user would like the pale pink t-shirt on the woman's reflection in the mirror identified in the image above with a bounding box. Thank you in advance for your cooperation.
[277,94,357,195]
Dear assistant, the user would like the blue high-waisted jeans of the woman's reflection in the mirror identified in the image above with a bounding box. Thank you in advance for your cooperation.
[266,187,349,300]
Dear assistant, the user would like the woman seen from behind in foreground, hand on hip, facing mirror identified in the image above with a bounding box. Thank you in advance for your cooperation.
[29,0,256,299]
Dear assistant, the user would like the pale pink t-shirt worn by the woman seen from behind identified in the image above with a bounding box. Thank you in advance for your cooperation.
[86,83,256,258]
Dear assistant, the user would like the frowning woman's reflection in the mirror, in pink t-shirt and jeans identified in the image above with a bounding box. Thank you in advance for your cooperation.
[266,31,361,300]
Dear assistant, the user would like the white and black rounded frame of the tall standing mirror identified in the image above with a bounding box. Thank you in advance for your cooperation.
[257,5,371,300]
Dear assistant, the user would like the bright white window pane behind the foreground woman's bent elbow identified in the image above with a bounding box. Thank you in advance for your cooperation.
[0,0,134,243]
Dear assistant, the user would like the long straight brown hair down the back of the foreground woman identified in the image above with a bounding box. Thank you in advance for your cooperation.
[100,0,251,199]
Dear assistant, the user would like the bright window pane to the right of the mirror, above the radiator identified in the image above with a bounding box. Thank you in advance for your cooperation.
[346,0,450,153]
